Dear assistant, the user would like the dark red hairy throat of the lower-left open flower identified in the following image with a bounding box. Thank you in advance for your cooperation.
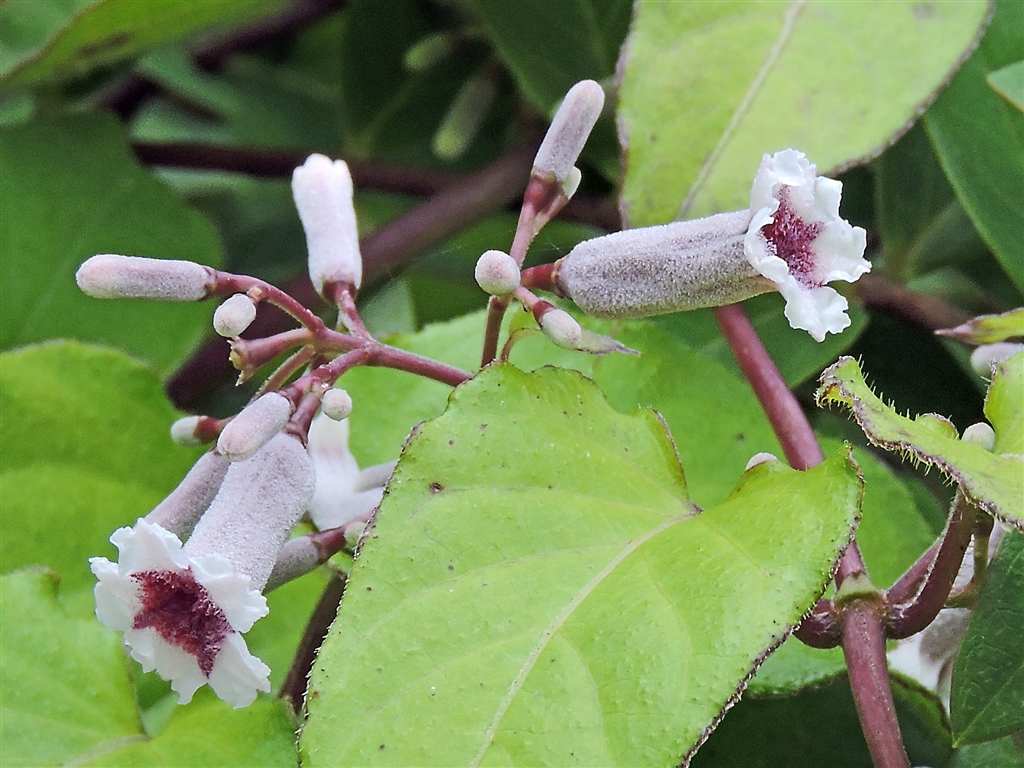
[131,570,232,678]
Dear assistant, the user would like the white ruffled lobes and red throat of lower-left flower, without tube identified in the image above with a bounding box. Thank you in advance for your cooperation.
[90,520,270,708]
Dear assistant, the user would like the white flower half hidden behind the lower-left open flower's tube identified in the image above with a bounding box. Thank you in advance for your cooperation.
[308,414,394,530]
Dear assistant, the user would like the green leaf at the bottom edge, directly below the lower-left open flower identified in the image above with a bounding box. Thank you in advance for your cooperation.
[78,688,296,768]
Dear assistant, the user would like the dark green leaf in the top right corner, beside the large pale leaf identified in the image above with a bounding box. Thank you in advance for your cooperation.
[925,0,1024,290]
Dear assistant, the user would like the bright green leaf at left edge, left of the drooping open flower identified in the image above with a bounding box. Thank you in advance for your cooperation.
[0,342,198,612]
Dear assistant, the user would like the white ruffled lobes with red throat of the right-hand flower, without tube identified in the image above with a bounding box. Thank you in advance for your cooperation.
[743,150,871,341]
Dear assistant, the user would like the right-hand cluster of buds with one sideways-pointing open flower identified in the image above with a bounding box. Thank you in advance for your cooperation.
[476,81,870,352]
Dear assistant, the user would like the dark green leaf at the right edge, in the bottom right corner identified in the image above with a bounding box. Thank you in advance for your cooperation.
[949,530,1024,745]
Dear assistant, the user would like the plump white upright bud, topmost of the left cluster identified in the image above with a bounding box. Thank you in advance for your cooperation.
[292,155,362,295]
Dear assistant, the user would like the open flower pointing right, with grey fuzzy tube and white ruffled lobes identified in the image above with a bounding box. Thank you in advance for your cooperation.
[553,150,871,341]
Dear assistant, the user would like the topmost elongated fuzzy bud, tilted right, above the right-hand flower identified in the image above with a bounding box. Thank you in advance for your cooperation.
[534,80,604,183]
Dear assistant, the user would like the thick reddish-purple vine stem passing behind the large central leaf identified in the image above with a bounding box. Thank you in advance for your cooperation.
[715,304,910,768]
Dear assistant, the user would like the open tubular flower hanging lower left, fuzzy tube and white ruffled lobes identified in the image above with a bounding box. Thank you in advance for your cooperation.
[90,433,314,709]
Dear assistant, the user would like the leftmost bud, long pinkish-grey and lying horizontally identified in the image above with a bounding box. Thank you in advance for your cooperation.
[75,253,215,301]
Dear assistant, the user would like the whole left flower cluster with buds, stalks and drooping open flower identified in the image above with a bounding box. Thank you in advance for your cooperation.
[77,155,403,708]
